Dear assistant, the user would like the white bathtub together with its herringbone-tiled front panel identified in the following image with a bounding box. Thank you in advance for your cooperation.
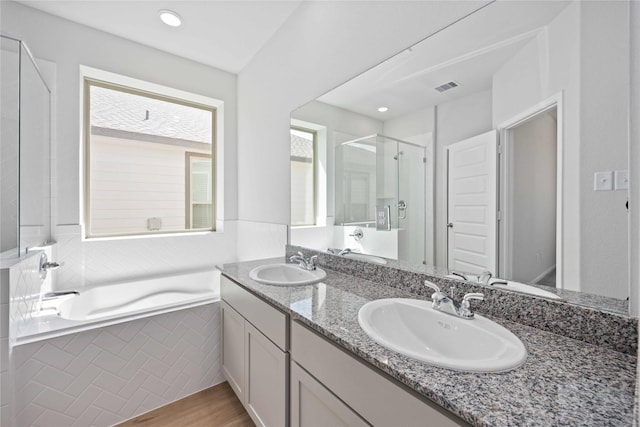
[11,270,224,427]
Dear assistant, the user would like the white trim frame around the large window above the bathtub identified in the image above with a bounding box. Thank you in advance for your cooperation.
[78,65,224,241]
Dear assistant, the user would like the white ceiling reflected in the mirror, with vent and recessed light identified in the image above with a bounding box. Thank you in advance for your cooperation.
[318,1,569,121]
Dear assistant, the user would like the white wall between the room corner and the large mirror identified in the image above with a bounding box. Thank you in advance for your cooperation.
[238,1,492,255]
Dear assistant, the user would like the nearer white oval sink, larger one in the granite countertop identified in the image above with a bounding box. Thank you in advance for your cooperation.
[358,298,527,372]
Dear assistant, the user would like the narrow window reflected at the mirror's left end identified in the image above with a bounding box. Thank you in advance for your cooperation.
[291,127,316,226]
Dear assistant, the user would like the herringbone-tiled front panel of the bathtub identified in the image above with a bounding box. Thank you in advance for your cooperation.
[12,302,223,427]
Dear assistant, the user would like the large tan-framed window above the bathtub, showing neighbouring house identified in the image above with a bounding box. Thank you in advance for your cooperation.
[84,77,216,237]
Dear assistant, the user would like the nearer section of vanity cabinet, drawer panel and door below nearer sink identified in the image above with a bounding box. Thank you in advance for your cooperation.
[291,321,468,427]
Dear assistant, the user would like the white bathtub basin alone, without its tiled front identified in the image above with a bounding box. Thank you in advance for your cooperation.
[55,270,220,321]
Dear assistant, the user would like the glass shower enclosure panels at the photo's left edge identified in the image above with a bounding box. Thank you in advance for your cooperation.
[0,35,51,259]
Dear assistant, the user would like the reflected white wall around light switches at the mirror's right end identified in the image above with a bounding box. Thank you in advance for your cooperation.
[580,2,638,299]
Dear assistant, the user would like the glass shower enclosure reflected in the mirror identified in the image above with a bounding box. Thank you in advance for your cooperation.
[335,134,426,263]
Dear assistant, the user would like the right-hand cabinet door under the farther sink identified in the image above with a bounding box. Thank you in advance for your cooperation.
[244,322,289,427]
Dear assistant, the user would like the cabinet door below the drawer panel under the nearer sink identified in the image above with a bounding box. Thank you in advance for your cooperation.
[291,363,370,427]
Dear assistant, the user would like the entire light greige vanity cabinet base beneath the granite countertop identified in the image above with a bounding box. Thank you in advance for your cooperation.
[220,276,468,427]
